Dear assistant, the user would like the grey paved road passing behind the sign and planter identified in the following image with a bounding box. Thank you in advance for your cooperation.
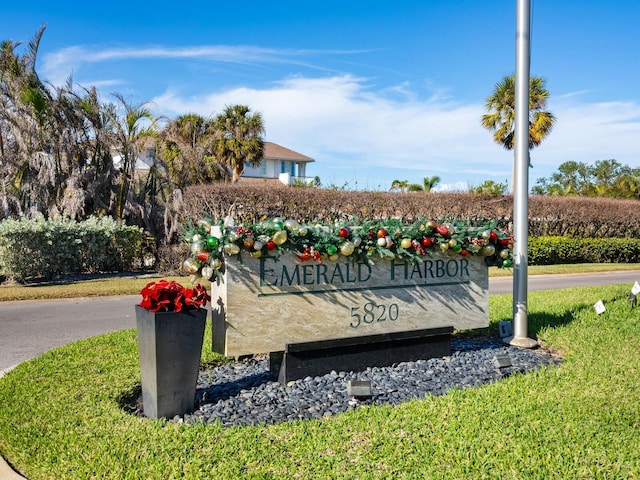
[0,271,640,371]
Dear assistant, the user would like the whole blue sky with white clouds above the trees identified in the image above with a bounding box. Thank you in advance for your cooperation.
[5,0,640,190]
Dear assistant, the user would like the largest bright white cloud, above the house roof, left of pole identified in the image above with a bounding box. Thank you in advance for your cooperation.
[154,75,502,176]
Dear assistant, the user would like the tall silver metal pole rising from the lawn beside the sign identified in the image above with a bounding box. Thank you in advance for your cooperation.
[504,0,537,348]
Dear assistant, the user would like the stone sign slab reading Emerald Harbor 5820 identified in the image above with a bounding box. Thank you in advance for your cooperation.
[211,253,489,356]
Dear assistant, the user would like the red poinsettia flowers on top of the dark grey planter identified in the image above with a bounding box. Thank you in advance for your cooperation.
[140,280,211,312]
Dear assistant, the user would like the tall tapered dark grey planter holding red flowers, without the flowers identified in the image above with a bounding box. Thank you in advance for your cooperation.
[136,305,207,418]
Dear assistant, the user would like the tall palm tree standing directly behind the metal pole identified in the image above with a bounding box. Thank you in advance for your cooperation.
[482,75,556,192]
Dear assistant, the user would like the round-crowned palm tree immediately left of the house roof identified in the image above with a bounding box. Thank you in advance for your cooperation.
[213,105,265,183]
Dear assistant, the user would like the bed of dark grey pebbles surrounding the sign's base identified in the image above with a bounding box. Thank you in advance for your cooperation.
[172,337,558,427]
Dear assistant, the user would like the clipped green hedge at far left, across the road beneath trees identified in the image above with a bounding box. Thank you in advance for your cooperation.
[0,217,142,282]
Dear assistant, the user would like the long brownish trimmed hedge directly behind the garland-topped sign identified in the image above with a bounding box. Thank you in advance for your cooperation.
[179,181,640,238]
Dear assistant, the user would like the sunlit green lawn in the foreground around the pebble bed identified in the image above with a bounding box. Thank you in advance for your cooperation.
[0,286,640,480]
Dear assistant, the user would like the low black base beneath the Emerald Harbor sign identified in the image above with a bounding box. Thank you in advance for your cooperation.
[270,327,453,385]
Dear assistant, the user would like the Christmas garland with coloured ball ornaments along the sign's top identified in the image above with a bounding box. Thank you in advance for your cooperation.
[182,217,513,284]
